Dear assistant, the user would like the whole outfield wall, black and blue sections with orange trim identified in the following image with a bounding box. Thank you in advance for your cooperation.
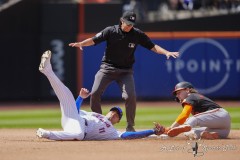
[0,0,240,102]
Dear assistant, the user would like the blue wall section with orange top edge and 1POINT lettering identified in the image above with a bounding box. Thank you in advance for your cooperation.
[79,32,240,99]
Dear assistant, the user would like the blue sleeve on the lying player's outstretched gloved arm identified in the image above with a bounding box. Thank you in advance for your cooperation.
[121,129,155,139]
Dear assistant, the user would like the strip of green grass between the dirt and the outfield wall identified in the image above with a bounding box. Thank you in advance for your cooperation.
[0,107,240,129]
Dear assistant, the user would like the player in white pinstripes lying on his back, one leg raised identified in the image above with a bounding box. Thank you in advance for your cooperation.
[37,51,164,140]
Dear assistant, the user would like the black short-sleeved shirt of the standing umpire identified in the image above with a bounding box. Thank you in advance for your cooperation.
[93,25,154,69]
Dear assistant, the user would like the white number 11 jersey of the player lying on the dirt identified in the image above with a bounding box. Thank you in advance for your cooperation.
[80,110,121,140]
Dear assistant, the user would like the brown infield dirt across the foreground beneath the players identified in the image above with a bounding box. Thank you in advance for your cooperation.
[0,129,240,160]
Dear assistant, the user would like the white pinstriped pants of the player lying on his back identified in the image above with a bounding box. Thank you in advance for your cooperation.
[42,64,85,140]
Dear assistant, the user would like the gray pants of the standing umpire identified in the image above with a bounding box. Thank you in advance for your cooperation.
[90,65,136,126]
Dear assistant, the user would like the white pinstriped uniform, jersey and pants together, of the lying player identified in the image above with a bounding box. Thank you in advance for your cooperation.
[41,58,121,140]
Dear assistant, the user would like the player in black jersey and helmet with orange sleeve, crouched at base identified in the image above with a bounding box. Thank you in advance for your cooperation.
[165,82,231,139]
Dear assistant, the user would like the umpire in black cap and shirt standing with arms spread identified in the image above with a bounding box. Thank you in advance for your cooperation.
[69,11,179,131]
